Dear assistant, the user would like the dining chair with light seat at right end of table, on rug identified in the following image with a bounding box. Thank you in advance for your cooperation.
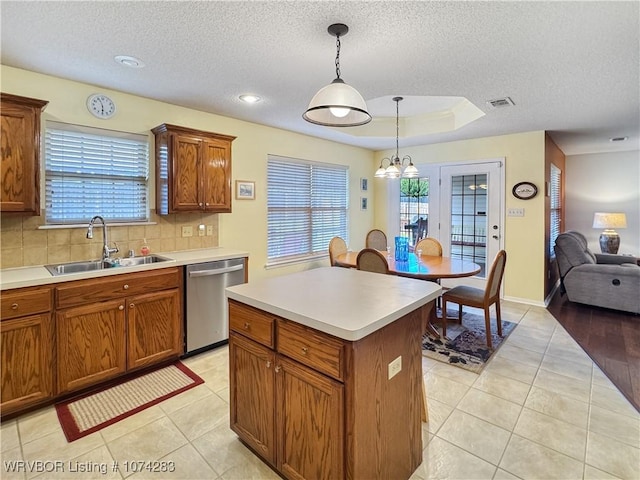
[442,250,507,348]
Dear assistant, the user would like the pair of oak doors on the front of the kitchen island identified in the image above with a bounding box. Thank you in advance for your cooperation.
[229,332,344,479]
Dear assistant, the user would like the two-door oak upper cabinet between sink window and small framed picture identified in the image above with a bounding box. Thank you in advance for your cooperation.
[151,123,236,215]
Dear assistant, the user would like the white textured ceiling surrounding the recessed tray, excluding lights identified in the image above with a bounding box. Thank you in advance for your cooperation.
[0,0,640,155]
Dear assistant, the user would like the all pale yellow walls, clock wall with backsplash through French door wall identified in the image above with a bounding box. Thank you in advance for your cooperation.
[0,66,556,303]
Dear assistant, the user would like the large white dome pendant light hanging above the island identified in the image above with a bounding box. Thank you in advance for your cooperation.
[302,23,371,127]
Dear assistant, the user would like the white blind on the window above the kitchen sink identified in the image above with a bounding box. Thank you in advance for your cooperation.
[45,122,149,224]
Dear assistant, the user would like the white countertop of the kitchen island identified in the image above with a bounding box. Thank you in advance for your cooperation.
[226,267,441,341]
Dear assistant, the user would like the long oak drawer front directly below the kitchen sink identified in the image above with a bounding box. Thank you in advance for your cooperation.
[56,267,180,308]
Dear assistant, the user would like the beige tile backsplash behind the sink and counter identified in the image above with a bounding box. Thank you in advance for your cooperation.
[0,211,218,268]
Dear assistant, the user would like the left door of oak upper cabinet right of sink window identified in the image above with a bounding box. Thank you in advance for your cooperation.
[170,135,203,212]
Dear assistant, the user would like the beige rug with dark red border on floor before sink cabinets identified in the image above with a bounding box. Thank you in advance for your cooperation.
[56,362,204,442]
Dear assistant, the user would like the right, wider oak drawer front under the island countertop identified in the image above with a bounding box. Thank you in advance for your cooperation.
[277,320,344,380]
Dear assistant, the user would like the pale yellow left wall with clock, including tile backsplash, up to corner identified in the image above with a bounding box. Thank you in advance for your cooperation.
[0,66,373,279]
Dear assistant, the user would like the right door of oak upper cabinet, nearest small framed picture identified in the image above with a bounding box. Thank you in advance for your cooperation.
[202,140,231,213]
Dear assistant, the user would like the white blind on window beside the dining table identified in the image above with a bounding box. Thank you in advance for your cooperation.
[267,156,349,262]
